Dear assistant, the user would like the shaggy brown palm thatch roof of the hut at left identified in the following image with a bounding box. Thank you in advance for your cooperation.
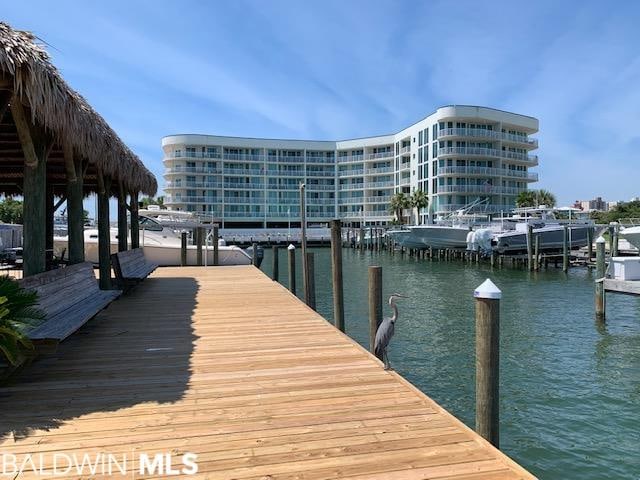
[0,22,157,195]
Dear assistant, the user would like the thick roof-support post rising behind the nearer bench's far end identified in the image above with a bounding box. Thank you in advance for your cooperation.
[63,148,84,264]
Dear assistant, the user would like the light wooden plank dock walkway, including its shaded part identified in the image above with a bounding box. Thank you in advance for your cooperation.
[0,267,534,480]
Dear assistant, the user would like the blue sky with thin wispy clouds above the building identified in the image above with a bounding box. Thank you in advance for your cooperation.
[2,0,640,204]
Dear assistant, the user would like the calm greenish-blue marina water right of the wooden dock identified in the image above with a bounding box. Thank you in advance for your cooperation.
[262,249,640,480]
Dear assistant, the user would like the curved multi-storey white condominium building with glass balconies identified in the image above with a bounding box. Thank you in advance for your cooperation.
[162,105,538,228]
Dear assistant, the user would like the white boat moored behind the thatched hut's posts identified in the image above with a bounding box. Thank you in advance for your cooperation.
[53,216,252,266]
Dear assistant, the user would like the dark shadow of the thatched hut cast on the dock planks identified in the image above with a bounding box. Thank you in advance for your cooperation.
[0,277,199,442]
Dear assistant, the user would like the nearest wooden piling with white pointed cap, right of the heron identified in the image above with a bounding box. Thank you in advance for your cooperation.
[473,279,502,448]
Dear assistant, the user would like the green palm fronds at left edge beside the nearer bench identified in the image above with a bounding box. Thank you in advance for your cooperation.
[0,276,45,366]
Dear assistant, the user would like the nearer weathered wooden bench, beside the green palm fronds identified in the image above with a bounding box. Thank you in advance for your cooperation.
[20,262,122,350]
